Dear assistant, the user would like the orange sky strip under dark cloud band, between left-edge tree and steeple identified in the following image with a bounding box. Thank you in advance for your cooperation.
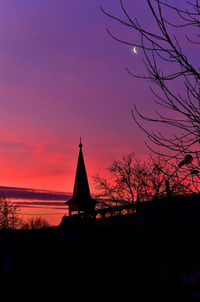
[10,199,68,226]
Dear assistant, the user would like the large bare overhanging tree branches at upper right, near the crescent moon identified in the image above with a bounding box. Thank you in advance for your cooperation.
[101,0,200,187]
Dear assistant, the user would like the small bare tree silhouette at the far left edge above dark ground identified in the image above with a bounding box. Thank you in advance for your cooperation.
[0,195,23,229]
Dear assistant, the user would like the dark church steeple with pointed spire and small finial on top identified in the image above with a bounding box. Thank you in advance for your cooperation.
[66,139,96,216]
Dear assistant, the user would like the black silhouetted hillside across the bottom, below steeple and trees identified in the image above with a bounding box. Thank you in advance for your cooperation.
[0,195,200,301]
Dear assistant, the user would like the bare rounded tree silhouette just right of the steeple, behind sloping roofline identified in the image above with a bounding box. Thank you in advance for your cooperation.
[94,153,191,206]
